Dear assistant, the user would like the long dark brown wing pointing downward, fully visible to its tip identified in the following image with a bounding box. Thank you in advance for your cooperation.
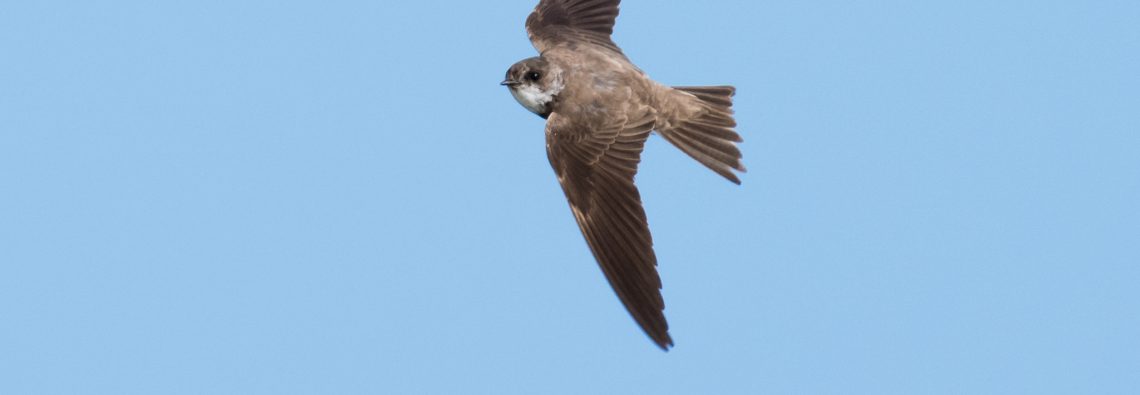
[546,111,673,349]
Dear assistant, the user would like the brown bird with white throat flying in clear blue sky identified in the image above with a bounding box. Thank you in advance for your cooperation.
[500,0,747,352]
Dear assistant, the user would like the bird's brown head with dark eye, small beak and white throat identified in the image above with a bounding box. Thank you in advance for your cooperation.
[502,57,562,118]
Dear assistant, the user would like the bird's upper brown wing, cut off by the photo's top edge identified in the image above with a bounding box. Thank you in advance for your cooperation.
[527,0,621,54]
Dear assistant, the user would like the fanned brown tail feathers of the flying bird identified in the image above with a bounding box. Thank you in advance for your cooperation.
[658,87,747,184]
